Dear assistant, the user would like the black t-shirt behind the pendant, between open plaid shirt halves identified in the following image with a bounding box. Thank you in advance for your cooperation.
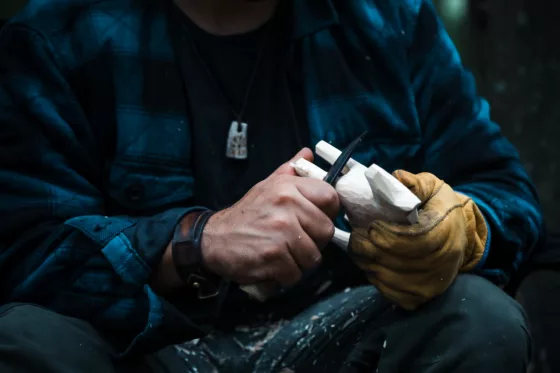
[175,4,308,210]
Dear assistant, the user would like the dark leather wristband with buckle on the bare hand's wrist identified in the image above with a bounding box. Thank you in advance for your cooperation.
[171,210,222,299]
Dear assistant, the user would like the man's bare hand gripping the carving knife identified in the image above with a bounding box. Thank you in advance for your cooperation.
[202,149,339,286]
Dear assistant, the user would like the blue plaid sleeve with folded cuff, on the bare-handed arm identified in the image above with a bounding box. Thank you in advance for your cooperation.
[0,24,221,354]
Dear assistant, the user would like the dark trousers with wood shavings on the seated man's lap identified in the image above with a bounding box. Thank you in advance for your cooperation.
[0,275,530,373]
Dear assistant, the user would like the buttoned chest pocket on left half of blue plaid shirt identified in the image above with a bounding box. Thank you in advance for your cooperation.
[106,112,194,214]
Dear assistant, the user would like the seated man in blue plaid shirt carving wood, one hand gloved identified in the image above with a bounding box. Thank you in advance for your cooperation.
[0,0,542,372]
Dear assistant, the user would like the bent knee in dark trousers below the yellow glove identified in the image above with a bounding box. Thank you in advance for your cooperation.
[354,275,531,373]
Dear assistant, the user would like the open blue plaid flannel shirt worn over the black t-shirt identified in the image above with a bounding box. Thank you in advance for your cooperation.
[0,0,542,354]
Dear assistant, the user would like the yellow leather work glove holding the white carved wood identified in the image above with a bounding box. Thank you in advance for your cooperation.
[350,170,488,310]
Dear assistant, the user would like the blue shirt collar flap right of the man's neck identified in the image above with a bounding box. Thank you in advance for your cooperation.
[290,0,339,39]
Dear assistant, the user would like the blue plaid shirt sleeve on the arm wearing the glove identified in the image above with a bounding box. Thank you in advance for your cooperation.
[408,0,543,284]
